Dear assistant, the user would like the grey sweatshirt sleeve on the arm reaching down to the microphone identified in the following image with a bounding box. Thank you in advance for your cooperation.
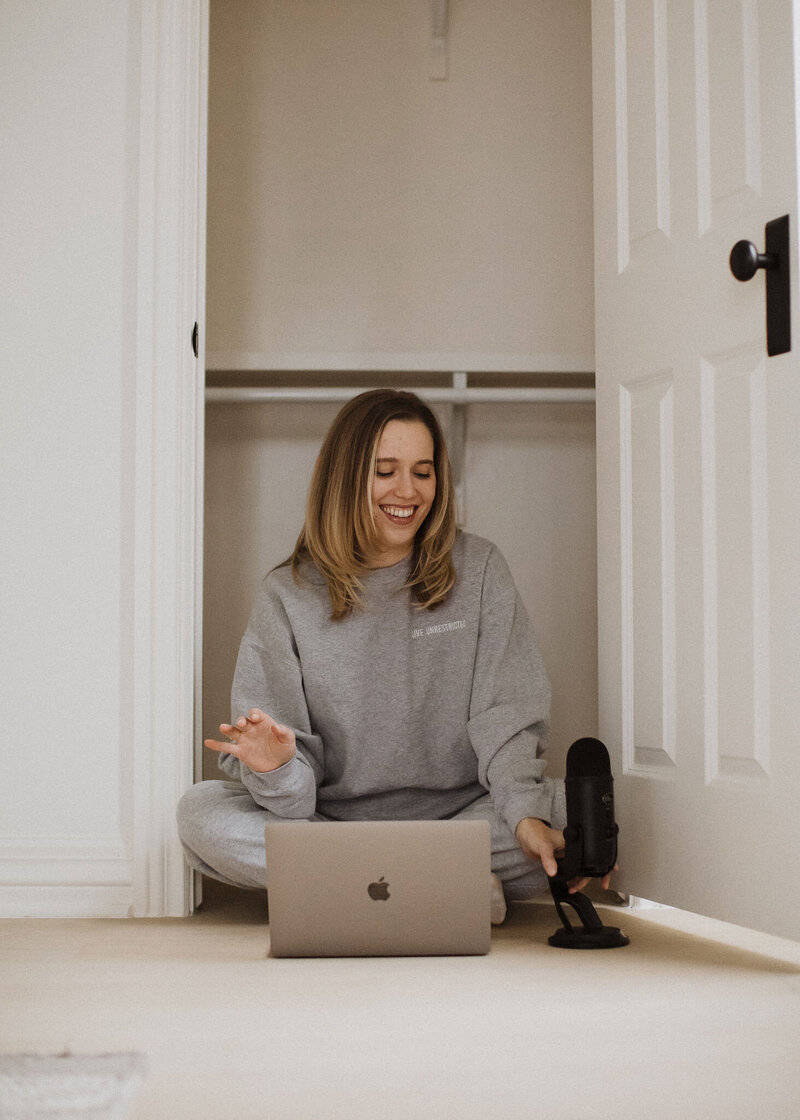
[467,548,555,832]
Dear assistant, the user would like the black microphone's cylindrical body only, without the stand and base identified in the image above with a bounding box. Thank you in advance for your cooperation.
[560,739,620,879]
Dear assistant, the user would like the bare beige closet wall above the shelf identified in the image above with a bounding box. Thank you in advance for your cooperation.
[208,0,594,372]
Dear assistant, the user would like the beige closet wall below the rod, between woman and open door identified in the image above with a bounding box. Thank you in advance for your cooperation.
[466,404,597,775]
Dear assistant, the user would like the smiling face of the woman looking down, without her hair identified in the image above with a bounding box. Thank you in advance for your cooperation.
[372,420,436,568]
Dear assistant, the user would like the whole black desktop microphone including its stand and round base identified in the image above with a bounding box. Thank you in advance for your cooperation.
[548,738,629,949]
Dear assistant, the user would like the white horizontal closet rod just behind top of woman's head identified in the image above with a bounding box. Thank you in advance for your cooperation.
[205,385,595,404]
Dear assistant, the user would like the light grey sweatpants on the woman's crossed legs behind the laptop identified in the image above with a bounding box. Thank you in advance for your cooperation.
[178,781,567,899]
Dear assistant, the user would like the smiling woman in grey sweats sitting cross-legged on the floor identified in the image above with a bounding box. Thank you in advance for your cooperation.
[178,390,607,923]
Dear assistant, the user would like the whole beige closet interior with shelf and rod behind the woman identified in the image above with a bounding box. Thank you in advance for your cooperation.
[202,0,597,777]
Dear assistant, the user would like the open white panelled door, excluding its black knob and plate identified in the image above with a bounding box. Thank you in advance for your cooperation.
[593,0,800,937]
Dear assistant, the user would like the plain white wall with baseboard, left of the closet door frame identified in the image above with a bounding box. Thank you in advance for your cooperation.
[0,0,138,911]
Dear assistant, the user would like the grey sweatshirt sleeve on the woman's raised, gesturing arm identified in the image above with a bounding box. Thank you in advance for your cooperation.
[220,586,323,819]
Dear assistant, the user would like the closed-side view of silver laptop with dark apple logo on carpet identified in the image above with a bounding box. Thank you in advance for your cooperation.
[266,821,492,956]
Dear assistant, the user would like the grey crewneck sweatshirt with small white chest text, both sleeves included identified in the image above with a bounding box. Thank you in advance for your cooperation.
[220,533,554,832]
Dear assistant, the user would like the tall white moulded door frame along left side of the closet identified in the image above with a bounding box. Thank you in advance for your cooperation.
[130,0,208,917]
